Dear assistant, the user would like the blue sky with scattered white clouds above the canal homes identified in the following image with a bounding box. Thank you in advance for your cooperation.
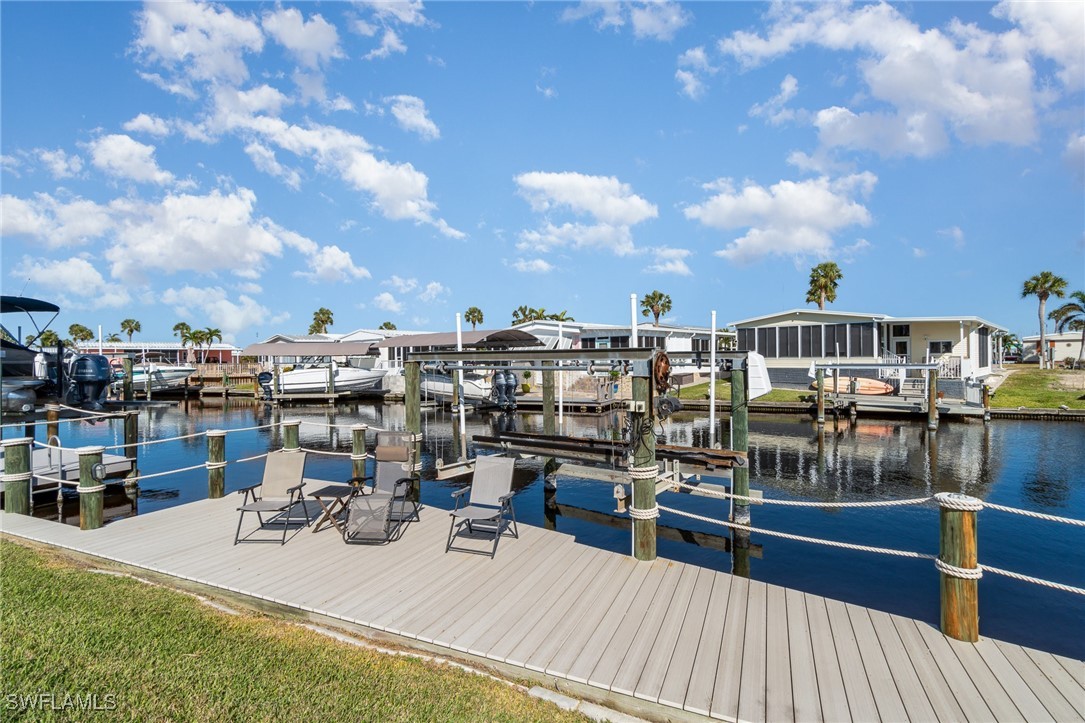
[0,2,1085,345]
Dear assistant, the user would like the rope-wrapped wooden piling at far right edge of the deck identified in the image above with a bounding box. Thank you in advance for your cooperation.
[935,493,983,643]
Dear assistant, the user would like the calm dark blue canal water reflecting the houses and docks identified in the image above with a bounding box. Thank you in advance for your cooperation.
[4,401,1085,659]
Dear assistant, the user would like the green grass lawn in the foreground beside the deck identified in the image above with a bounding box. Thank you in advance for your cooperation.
[0,540,586,721]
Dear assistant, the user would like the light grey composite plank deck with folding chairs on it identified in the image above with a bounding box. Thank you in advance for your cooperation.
[0,495,1085,722]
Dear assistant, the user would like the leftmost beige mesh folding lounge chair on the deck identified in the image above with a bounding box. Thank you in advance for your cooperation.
[233,449,310,545]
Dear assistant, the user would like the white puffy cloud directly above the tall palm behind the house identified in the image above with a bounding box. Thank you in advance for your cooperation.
[684,172,878,263]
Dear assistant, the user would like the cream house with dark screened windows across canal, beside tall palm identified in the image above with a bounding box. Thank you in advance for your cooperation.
[730,308,1008,396]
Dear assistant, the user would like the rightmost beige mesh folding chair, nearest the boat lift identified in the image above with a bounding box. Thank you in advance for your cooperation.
[445,456,520,558]
